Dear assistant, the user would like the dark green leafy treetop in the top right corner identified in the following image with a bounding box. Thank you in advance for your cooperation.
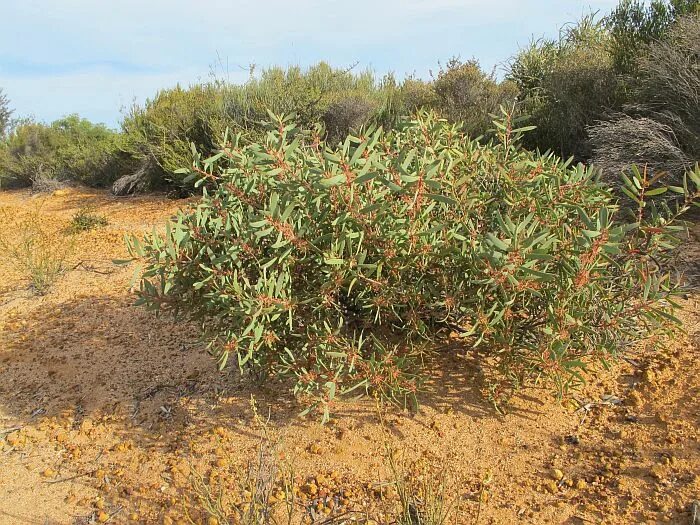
[605,0,700,74]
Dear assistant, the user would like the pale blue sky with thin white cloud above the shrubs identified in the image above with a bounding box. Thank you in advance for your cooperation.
[0,0,617,127]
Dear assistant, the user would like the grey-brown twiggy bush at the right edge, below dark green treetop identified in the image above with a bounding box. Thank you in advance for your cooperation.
[589,16,700,184]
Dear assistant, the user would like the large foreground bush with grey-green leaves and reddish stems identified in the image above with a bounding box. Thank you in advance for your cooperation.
[130,111,700,418]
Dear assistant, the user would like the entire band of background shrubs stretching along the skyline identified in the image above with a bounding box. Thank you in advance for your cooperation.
[0,0,700,194]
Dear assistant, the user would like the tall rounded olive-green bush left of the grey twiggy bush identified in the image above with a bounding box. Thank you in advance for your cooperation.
[509,16,624,160]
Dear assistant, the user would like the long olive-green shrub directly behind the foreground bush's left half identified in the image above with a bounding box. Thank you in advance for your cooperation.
[123,62,402,190]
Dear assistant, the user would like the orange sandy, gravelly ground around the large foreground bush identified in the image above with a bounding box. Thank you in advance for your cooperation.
[0,190,700,524]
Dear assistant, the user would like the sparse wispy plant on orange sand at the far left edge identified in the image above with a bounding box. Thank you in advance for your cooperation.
[0,208,74,295]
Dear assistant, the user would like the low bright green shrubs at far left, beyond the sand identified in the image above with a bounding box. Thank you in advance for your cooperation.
[0,115,123,186]
